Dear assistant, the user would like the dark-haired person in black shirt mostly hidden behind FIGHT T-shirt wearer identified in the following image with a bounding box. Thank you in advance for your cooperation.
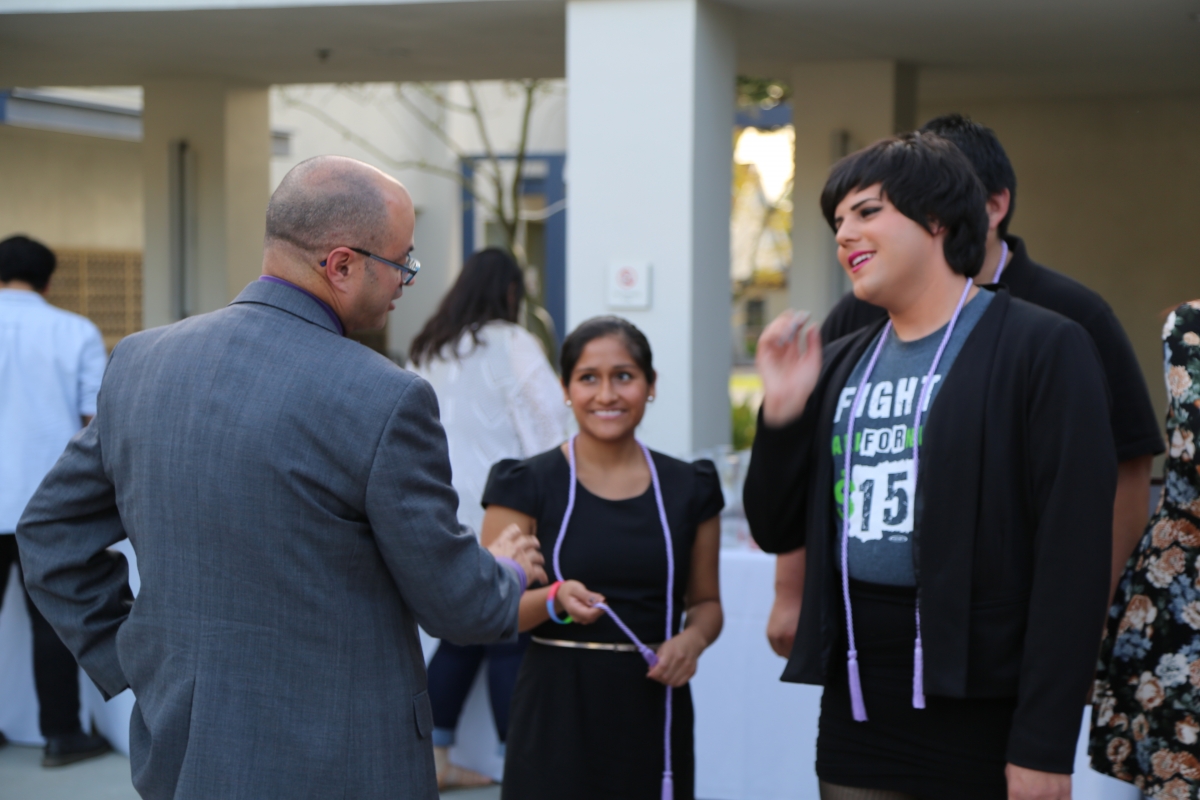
[767,114,1164,681]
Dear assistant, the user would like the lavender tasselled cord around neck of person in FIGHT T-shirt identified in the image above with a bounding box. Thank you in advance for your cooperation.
[844,278,974,722]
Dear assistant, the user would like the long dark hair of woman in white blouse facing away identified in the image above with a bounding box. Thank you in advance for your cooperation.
[408,247,524,366]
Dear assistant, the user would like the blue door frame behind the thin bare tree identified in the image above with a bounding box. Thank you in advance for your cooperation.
[460,152,566,344]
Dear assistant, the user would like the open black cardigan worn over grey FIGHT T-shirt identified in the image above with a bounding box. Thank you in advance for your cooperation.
[744,287,1117,772]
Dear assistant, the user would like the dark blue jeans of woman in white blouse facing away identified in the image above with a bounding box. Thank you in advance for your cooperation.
[428,633,529,747]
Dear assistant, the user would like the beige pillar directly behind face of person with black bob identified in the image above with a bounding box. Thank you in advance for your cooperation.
[788,61,917,319]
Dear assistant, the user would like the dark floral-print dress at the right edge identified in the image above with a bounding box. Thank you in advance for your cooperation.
[1090,301,1200,800]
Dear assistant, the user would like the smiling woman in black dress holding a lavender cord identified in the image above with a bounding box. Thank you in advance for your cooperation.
[482,317,724,800]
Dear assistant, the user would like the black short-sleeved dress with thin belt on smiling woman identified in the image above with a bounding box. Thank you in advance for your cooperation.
[484,447,725,800]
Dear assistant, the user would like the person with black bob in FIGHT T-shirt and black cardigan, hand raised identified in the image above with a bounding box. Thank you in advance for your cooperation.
[744,133,1116,800]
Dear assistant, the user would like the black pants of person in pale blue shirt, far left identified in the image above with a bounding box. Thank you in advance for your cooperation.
[0,534,80,738]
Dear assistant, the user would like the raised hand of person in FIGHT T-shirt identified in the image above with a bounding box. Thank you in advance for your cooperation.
[755,311,821,427]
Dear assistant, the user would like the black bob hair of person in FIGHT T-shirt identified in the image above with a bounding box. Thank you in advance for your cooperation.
[821,131,988,278]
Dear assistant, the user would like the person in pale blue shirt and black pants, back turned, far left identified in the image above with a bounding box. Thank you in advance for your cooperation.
[0,236,109,766]
